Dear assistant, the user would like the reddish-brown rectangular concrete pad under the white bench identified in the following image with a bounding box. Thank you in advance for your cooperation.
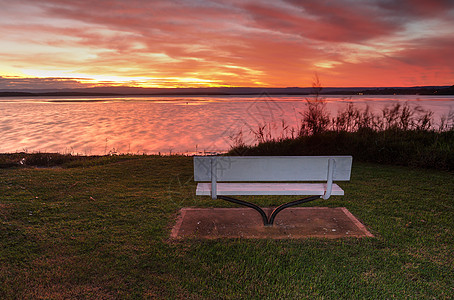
[171,207,373,239]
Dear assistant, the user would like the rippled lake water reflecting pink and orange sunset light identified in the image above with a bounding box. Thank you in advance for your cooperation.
[0,95,454,155]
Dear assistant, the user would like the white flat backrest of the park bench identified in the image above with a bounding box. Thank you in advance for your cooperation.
[194,156,352,182]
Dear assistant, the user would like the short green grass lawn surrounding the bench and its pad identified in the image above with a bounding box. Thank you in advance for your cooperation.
[0,156,454,299]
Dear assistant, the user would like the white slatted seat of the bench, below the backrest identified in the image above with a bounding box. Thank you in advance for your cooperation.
[196,182,344,196]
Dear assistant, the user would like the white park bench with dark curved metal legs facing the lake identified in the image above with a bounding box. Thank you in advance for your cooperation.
[194,156,352,226]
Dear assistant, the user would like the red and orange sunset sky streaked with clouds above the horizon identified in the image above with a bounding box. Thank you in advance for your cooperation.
[0,0,454,89]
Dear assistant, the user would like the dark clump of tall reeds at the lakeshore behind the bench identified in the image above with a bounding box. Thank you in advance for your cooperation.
[228,95,454,170]
